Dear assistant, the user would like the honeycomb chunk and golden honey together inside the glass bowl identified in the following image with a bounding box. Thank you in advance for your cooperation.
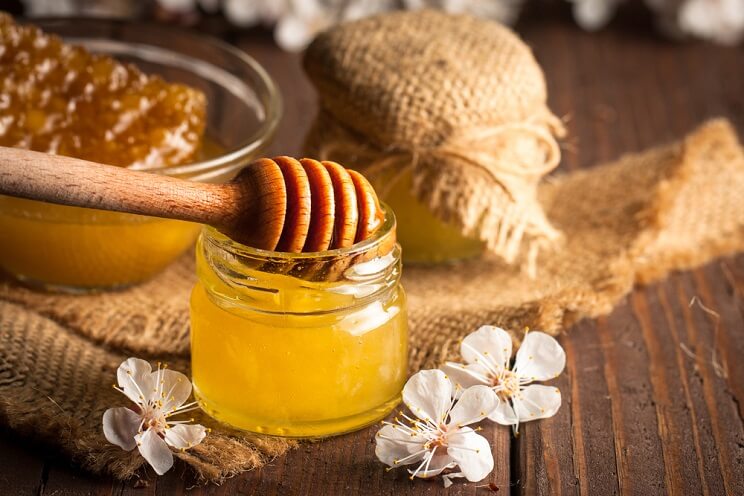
[0,14,222,290]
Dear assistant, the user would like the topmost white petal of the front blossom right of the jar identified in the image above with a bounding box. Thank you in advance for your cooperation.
[403,370,452,424]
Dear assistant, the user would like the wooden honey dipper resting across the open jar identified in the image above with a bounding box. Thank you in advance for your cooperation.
[0,147,383,252]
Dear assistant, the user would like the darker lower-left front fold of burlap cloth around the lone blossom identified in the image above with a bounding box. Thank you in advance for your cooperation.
[0,301,297,483]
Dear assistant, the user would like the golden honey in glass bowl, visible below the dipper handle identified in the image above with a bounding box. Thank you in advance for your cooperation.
[0,196,200,290]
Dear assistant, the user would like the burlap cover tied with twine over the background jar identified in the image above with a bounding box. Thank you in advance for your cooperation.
[304,10,564,262]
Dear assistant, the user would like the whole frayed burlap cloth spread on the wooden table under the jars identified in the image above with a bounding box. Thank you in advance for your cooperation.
[0,120,744,481]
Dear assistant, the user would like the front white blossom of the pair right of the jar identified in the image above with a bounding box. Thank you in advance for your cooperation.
[375,370,498,486]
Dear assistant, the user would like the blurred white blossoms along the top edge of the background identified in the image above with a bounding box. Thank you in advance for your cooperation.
[7,0,744,51]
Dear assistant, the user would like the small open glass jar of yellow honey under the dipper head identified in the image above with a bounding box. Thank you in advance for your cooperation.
[191,207,408,437]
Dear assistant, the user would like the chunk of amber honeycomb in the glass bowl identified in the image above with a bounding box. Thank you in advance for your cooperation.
[0,13,206,169]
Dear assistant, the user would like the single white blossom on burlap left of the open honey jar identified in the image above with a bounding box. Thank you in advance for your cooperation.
[103,358,208,475]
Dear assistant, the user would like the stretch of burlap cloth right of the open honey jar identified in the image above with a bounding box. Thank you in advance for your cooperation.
[404,119,744,370]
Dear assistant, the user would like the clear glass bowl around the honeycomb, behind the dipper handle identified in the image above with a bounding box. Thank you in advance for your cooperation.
[0,19,282,292]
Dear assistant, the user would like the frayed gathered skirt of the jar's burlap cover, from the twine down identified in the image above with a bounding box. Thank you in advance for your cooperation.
[304,109,565,263]
